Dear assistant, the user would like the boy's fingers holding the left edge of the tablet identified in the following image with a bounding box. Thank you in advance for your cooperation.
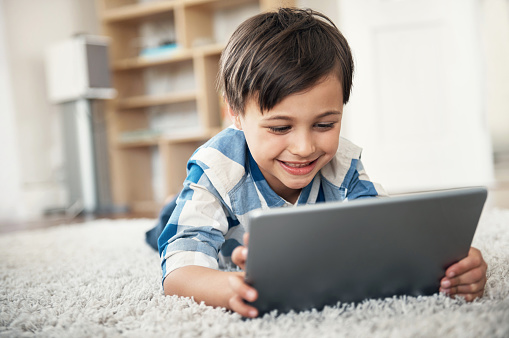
[229,233,258,318]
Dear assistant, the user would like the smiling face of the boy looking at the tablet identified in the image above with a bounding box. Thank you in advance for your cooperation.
[234,76,343,203]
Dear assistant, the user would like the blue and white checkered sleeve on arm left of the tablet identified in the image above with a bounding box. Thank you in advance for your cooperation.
[158,164,228,281]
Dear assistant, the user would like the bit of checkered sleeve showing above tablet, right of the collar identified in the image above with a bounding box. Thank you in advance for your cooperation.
[346,159,387,200]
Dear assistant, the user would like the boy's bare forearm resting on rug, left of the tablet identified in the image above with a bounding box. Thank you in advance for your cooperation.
[164,265,243,308]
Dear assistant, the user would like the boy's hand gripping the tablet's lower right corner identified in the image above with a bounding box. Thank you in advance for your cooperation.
[440,247,488,302]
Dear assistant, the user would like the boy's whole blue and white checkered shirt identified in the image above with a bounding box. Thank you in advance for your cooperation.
[159,127,385,280]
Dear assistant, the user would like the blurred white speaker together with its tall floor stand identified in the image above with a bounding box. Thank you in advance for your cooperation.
[45,34,116,215]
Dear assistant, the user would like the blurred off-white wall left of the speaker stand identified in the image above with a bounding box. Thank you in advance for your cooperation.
[0,0,99,222]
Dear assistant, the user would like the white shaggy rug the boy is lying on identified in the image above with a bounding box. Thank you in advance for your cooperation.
[0,210,509,337]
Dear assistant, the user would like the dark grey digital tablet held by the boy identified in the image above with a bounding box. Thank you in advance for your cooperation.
[246,187,487,314]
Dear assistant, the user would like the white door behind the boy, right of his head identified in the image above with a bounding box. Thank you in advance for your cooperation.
[339,0,493,193]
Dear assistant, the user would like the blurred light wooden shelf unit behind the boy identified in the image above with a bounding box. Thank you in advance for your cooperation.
[96,0,295,215]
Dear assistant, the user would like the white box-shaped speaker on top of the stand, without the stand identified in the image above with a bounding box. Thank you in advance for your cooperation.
[45,35,116,103]
